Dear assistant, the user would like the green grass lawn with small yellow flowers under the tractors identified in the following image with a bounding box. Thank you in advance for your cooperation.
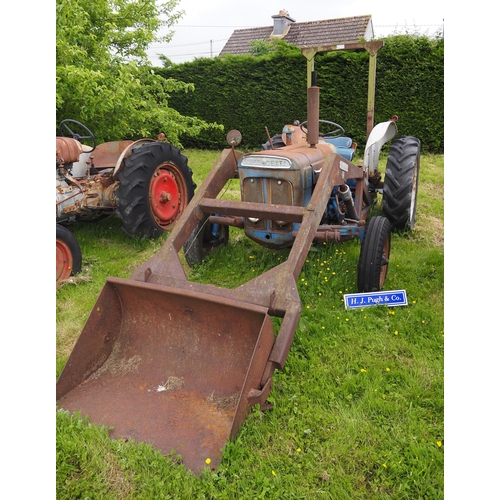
[56,150,444,500]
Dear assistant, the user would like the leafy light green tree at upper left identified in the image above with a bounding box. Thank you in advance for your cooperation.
[56,0,221,145]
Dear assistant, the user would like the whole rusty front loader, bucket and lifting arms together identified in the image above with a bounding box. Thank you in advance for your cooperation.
[57,85,363,472]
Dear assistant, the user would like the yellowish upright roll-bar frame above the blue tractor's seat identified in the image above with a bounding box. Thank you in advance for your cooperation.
[302,40,384,137]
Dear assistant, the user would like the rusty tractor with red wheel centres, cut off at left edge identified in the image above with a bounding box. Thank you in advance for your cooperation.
[56,120,196,283]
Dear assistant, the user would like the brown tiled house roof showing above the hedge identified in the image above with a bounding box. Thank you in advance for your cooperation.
[219,15,373,55]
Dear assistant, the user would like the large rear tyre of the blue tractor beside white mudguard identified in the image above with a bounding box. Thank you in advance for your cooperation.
[382,136,420,231]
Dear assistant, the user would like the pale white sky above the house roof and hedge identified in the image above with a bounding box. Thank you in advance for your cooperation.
[148,0,444,66]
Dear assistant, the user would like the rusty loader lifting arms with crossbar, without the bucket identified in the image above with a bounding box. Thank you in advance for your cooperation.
[131,149,357,392]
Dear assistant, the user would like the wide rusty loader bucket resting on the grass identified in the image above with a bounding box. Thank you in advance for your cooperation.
[57,278,274,470]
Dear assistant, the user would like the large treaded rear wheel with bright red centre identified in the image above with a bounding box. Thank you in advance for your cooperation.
[115,142,196,238]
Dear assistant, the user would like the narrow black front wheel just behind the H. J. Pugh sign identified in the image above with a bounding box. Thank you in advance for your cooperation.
[358,215,391,293]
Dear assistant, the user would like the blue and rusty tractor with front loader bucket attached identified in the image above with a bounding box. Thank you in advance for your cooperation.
[57,43,419,473]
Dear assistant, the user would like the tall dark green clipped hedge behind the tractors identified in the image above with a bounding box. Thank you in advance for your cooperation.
[159,35,444,153]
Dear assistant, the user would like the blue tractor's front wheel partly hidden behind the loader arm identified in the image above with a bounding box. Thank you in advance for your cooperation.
[184,215,229,267]
